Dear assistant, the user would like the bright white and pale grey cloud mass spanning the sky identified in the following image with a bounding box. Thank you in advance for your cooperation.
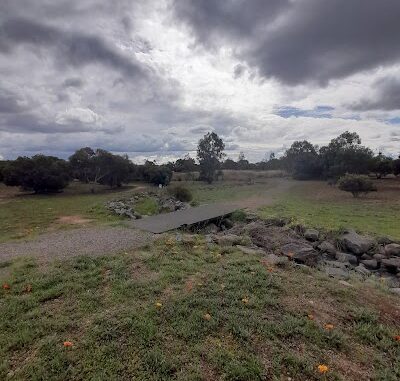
[0,0,400,161]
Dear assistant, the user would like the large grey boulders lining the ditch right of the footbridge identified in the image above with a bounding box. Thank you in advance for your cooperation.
[212,219,400,290]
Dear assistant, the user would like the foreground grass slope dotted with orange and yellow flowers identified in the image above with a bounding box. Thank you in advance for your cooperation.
[0,236,400,381]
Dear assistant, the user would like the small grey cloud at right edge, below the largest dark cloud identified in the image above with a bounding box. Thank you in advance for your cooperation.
[350,77,400,111]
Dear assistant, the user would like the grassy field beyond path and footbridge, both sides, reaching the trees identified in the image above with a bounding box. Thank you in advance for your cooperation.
[0,177,400,242]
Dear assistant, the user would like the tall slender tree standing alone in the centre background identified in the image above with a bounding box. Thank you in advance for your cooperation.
[197,132,225,184]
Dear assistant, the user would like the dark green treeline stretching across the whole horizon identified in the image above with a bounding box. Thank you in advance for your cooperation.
[0,132,400,193]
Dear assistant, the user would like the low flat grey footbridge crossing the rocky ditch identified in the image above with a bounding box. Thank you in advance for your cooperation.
[133,204,238,233]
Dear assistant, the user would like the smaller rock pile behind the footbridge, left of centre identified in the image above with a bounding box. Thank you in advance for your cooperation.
[106,192,190,220]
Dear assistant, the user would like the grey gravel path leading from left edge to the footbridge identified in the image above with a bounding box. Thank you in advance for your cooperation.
[0,227,154,261]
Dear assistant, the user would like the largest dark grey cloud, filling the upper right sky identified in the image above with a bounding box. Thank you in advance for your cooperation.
[174,0,400,85]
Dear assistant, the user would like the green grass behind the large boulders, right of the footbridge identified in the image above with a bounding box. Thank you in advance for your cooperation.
[260,180,400,239]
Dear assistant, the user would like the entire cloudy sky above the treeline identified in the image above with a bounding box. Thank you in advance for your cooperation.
[0,0,400,161]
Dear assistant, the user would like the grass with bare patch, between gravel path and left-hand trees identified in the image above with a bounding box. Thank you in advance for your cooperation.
[0,183,148,242]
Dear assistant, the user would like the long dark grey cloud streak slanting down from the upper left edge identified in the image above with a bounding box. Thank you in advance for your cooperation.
[0,18,145,77]
